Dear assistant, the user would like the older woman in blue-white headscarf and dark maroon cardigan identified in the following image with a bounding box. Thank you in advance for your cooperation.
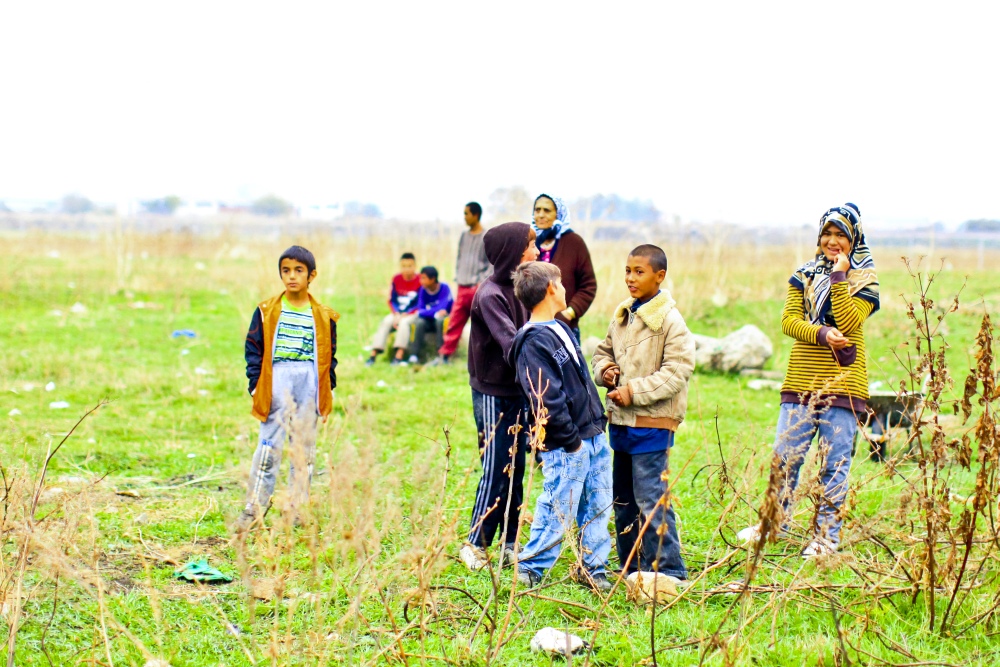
[531,194,597,342]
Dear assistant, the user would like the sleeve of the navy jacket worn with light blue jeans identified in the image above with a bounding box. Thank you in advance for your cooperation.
[515,332,580,452]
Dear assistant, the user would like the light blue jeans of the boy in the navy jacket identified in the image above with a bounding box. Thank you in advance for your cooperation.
[518,433,612,575]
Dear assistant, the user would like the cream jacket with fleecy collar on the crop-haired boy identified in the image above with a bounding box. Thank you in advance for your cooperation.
[593,290,694,431]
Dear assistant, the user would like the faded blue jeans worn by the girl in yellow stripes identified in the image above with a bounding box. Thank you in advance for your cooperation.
[774,403,858,544]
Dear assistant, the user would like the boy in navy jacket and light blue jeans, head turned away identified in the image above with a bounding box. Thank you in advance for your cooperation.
[512,262,611,591]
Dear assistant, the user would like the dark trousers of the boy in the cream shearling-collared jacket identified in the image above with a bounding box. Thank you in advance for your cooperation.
[612,450,687,579]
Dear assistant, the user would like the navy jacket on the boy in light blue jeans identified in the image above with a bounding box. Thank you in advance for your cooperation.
[511,320,608,452]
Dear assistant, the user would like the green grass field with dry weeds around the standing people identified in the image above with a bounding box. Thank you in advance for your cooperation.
[0,230,1000,667]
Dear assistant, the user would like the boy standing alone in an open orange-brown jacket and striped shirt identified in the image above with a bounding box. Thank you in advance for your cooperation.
[234,246,340,534]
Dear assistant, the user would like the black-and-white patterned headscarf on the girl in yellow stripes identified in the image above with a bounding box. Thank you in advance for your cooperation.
[788,203,879,325]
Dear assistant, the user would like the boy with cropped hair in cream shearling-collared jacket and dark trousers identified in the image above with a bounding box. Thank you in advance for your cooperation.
[593,245,694,583]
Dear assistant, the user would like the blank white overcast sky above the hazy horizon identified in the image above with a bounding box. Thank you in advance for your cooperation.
[0,0,1000,229]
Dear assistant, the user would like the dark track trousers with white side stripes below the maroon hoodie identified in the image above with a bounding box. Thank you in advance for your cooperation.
[469,389,528,547]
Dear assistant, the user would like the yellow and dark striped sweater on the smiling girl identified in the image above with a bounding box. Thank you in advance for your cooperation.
[781,280,874,410]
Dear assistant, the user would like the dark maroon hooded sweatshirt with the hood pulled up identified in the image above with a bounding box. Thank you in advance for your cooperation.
[469,222,531,397]
